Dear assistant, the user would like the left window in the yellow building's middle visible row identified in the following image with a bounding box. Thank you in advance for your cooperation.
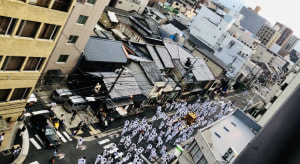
[1,56,25,71]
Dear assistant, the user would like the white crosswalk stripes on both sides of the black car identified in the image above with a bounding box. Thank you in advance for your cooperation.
[29,131,73,150]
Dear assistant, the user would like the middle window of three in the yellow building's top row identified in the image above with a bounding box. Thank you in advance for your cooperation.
[16,20,41,38]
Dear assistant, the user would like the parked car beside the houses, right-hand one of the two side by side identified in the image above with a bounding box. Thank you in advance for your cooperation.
[63,95,88,113]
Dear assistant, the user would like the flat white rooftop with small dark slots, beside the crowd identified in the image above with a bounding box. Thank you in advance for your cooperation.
[201,110,261,160]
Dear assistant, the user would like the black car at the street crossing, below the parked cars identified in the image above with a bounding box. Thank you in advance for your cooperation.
[30,115,62,147]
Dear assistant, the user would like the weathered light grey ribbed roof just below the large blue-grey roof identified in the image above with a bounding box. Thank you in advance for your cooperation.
[102,73,142,98]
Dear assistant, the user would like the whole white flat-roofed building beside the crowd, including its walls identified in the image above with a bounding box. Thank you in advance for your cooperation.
[179,110,261,164]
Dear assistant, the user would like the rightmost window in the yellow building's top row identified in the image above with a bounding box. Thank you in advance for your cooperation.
[39,23,60,40]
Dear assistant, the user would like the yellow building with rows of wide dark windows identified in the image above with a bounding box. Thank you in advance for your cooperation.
[0,0,75,148]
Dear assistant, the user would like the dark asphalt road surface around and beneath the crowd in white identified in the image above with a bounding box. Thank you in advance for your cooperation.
[24,98,234,164]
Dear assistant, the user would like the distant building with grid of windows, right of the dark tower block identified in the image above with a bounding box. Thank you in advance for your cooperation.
[256,24,275,46]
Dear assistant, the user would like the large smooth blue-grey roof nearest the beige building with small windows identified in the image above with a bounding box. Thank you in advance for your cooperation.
[84,37,127,63]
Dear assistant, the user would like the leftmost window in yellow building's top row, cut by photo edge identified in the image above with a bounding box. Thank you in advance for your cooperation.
[0,16,17,35]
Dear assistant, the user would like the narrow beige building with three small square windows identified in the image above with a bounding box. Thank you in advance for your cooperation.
[44,0,109,75]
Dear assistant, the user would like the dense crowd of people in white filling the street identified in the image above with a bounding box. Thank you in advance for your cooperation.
[95,96,233,164]
